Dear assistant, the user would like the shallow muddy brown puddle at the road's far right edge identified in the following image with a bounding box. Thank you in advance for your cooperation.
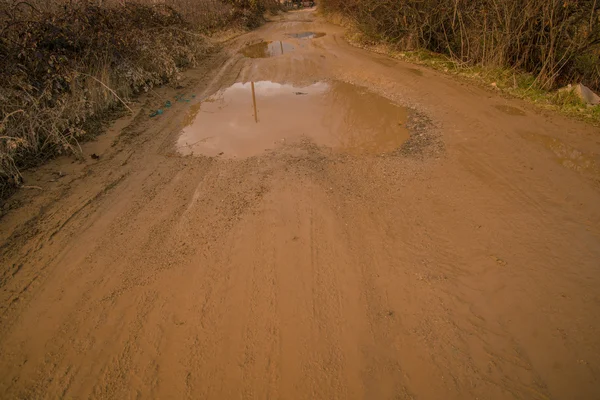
[519,131,600,178]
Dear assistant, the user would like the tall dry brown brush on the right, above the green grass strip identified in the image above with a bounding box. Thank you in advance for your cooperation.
[321,0,600,89]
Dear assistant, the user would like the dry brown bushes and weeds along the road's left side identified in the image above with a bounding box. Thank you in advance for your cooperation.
[0,0,278,199]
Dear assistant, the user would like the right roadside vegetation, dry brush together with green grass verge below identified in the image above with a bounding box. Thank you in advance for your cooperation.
[321,0,600,123]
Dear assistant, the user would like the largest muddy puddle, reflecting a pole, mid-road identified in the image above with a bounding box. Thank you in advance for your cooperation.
[177,81,409,158]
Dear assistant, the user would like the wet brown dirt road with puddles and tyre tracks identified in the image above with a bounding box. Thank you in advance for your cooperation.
[0,11,600,399]
